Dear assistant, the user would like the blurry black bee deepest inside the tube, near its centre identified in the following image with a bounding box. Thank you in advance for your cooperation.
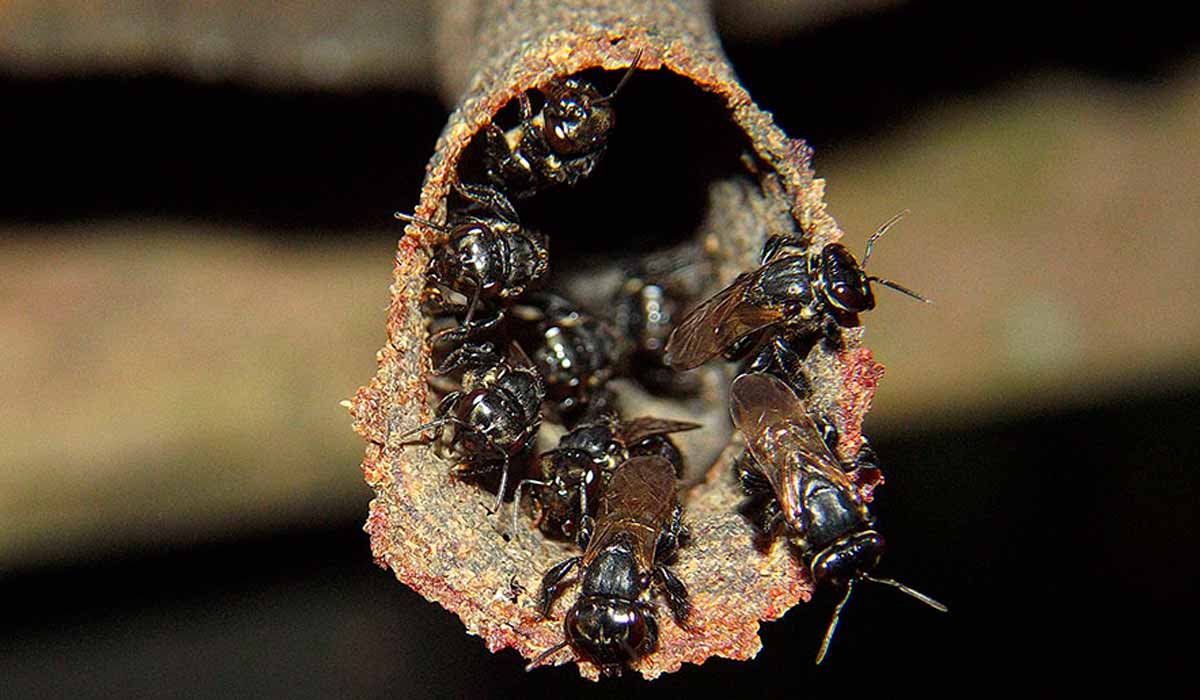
[613,274,700,396]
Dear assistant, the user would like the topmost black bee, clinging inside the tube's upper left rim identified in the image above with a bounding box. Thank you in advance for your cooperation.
[484,52,642,199]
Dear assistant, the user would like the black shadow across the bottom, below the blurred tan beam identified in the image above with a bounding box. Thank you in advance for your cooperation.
[0,393,1200,698]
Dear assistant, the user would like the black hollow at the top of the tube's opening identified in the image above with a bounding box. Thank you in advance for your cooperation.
[460,71,750,261]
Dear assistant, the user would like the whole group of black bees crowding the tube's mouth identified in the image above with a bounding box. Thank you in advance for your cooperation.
[396,56,944,674]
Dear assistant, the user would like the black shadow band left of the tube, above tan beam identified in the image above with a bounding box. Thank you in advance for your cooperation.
[0,74,446,238]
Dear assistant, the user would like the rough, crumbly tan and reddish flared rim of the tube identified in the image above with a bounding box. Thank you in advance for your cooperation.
[352,38,881,677]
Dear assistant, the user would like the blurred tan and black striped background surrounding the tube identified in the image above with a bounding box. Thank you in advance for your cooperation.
[0,0,1200,698]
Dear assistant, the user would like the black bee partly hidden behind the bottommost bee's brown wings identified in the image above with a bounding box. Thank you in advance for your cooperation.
[512,415,700,538]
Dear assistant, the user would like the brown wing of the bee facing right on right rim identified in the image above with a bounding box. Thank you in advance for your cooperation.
[666,273,784,371]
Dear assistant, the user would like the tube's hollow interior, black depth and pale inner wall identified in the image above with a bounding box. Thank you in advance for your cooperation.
[458,70,777,483]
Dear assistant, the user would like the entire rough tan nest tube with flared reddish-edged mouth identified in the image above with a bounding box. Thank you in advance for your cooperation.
[350,1,882,678]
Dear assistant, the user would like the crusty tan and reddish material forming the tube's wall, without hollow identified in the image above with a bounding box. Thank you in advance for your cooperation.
[350,0,882,678]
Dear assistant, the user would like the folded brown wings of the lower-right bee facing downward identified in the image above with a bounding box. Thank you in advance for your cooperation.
[730,372,853,527]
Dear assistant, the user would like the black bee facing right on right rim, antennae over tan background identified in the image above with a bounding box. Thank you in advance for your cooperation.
[666,215,929,381]
